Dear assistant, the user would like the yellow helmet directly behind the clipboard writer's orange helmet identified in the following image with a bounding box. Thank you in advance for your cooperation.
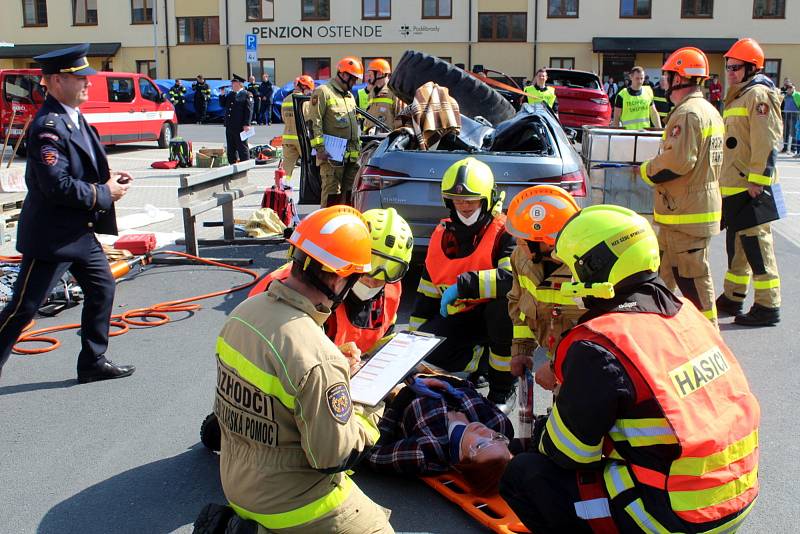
[364,208,414,283]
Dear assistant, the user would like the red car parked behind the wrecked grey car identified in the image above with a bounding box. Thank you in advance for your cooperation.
[547,69,611,132]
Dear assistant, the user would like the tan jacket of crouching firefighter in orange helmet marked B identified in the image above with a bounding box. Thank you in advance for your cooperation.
[508,246,586,358]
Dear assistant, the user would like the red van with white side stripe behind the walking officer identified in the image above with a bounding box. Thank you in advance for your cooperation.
[0,69,178,154]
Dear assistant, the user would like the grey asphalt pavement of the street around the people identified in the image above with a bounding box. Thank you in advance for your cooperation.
[0,126,800,534]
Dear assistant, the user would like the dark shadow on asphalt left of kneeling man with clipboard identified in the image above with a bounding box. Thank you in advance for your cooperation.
[37,443,225,534]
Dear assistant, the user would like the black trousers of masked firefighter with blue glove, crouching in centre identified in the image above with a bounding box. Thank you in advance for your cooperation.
[419,298,515,393]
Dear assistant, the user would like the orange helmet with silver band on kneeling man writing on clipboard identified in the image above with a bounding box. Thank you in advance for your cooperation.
[289,206,372,277]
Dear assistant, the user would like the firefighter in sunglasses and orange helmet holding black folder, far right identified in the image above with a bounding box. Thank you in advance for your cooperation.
[717,39,782,326]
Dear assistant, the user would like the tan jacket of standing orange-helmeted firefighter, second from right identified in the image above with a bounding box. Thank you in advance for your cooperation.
[640,91,724,237]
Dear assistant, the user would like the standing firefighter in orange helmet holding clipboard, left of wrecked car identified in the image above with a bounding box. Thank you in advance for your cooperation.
[308,57,364,207]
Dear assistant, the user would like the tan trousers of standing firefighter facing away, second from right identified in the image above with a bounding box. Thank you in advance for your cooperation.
[658,225,717,324]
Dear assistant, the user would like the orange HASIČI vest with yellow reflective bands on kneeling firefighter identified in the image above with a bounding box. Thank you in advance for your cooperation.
[546,301,760,532]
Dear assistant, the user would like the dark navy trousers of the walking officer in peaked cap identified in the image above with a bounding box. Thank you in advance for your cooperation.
[0,240,115,371]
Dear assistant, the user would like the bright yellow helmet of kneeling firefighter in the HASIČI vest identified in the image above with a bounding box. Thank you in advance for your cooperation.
[553,204,661,299]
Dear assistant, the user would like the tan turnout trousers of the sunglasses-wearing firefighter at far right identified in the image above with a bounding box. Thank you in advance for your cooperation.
[724,223,781,308]
